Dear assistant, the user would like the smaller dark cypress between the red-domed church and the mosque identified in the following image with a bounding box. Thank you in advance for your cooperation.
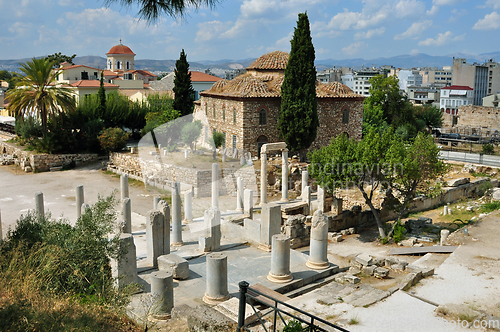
[174,49,195,116]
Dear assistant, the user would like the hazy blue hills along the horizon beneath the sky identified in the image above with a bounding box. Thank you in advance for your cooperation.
[0,52,500,75]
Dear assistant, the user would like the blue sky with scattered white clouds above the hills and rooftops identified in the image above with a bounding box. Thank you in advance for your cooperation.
[0,0,500,61]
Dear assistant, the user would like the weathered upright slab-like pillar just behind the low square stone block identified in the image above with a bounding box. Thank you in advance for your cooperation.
[146,210,166,267]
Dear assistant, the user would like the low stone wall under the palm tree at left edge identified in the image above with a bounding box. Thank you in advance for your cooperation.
[0,142,98,172]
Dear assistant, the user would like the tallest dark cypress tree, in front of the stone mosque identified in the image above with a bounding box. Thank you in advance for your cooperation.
[278,13,319,159]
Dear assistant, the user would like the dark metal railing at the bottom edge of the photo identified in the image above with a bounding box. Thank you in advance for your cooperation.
[237,281,349,332]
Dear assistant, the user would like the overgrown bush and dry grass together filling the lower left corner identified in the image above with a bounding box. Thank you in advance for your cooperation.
[0,196,137,331]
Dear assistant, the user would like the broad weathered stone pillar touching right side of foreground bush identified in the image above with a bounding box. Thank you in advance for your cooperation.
[111,233,137,288]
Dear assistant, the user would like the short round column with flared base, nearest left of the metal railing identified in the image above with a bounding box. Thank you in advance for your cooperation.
[203,252,229,305]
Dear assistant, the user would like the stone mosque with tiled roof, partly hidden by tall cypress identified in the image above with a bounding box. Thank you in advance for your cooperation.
[194,51,364,156]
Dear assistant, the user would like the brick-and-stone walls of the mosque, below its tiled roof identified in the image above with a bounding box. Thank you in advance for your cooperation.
[194,96,363,156]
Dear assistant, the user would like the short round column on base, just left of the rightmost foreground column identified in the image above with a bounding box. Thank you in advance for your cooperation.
[267,234,293,283]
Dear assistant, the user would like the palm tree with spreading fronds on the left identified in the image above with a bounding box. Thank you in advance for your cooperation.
[7,58,76,135]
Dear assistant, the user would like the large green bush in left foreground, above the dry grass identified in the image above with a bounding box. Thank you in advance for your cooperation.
[0,196,124,303]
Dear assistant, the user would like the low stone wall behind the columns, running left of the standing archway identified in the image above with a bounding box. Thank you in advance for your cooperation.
[108,152,258,197]
